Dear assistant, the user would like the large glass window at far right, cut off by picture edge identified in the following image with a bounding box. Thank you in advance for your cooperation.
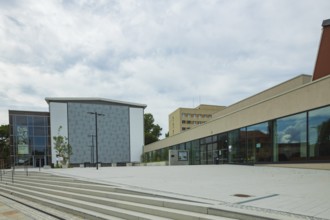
[308,106,330,160]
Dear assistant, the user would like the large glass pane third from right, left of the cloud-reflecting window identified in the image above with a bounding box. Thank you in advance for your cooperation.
[247,122,272,162]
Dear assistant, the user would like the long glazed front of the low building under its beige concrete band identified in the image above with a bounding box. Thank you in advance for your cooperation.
[145,106,330,165]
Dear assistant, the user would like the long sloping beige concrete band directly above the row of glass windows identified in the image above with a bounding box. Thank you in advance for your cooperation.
[144,76,330,152]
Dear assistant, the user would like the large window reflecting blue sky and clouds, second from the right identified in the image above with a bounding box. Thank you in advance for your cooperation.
[274,113,307,161]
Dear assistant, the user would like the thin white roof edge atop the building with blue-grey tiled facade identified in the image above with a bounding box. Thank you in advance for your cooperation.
[45,97,147,108]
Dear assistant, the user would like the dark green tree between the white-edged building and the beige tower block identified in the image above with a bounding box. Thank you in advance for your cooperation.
[144,113,162,145]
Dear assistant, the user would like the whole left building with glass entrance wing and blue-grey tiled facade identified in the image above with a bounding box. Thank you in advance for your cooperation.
[8,97,147,167]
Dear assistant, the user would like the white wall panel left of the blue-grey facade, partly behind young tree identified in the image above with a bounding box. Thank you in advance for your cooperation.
[49,102,68,164]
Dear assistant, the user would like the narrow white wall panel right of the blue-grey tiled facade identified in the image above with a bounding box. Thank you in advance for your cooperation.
[129,108,144,162]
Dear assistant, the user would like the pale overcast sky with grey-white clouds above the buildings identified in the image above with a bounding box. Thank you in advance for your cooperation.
[0,0,330,136]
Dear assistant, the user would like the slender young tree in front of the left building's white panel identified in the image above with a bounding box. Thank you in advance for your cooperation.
[53,126,72,165]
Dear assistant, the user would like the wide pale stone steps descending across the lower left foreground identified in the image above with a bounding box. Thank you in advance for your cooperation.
[0,170,269,220]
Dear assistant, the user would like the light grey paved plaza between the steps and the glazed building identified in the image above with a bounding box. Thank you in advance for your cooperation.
[42,165,330,219]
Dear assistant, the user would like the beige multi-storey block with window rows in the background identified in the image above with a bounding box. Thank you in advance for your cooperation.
[168,104,226,136]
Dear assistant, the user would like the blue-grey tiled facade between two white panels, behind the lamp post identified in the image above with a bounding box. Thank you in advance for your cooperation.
[68,102,130,164]
